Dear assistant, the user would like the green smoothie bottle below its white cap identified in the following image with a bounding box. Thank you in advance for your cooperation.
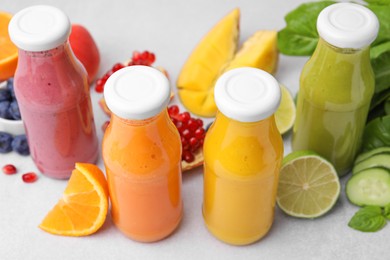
[292,39,375,176]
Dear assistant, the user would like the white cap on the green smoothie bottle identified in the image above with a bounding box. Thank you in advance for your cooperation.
[317,3,379,49]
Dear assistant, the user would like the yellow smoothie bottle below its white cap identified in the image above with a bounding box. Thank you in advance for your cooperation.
[203,112,283,245]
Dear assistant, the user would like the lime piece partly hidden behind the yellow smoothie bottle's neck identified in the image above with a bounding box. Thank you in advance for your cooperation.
[275,85,296,134]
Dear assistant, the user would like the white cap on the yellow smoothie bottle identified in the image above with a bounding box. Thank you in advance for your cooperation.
[214,67,281,122]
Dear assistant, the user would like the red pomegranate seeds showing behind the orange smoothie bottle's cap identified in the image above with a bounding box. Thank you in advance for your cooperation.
[95,51,156,93]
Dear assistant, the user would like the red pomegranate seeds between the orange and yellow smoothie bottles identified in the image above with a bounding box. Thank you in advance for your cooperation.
[168,105,206,163]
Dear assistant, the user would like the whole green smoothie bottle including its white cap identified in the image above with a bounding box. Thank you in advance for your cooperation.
[292,3,379,176]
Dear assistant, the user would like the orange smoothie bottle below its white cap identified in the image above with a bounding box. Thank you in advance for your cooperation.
[103,110,183,242]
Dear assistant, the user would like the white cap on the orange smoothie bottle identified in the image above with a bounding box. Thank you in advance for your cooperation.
[104,66,171,120]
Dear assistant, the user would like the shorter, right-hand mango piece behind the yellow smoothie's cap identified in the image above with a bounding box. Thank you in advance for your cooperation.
[224,31,279,73]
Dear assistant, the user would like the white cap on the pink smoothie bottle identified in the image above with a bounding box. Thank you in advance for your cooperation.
[8,5,71,51]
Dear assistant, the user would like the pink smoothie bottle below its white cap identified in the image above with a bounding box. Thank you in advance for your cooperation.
[14,43,98,179]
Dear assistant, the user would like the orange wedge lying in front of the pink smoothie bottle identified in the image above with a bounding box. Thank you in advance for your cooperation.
[39,163,108,236]
